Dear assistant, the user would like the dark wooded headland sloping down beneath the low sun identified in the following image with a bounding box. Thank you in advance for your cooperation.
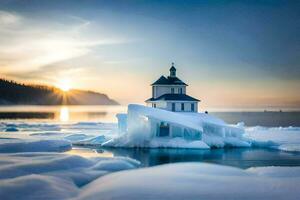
[0,79,120,106]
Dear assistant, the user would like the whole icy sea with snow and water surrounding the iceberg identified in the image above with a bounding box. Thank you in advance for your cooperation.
[0,106,300,199]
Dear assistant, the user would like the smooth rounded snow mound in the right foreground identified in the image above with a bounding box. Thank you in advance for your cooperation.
[79,163,300,200]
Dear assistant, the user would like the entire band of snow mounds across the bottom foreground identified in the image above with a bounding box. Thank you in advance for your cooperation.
[0,153,300,200]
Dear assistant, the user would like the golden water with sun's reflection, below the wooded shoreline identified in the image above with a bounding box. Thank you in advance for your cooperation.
[0,105,127,123]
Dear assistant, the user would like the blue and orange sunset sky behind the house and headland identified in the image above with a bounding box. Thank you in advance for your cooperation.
[0,0,300,109]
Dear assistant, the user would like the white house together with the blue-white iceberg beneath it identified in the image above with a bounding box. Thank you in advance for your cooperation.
[111,64,245,149]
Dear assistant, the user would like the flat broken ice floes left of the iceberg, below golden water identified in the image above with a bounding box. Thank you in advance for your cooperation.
[0,121,117,145]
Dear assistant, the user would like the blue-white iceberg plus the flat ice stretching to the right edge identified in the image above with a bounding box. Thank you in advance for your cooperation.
[99,104,300,151]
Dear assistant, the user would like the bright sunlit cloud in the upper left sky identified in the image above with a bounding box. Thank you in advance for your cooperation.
[0,11,126,74]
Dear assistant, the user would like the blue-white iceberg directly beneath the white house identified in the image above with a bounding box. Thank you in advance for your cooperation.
[102,104,251,149]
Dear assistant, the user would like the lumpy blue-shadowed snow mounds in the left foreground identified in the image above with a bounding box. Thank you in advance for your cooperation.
[0,153,139,199]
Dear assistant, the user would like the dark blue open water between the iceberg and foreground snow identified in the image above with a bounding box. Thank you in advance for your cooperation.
[98,148,300,168]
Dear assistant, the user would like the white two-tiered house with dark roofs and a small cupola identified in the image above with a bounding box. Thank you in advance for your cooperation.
[146,63,200,112]
